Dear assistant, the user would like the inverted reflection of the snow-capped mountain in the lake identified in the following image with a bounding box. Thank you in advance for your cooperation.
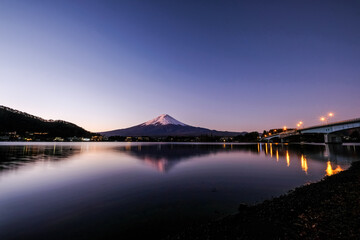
[116,144,257,172]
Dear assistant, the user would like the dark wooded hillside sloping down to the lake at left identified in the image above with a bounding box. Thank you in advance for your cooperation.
[0,105,92,137]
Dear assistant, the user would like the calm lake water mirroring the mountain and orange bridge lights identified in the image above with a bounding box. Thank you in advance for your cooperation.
[0,142,360,239]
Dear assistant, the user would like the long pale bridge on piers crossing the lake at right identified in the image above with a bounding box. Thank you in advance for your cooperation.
[261,118,360,143]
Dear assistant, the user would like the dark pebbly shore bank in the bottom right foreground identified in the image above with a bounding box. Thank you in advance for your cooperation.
[168,162,360,239]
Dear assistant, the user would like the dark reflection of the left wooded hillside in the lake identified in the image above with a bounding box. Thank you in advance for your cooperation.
[0,145,80,171]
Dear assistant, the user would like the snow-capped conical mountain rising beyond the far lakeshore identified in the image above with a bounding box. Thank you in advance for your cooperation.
[100,114,244,137]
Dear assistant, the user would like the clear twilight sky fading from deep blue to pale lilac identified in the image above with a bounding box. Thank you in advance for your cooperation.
[0,0,360,131]
